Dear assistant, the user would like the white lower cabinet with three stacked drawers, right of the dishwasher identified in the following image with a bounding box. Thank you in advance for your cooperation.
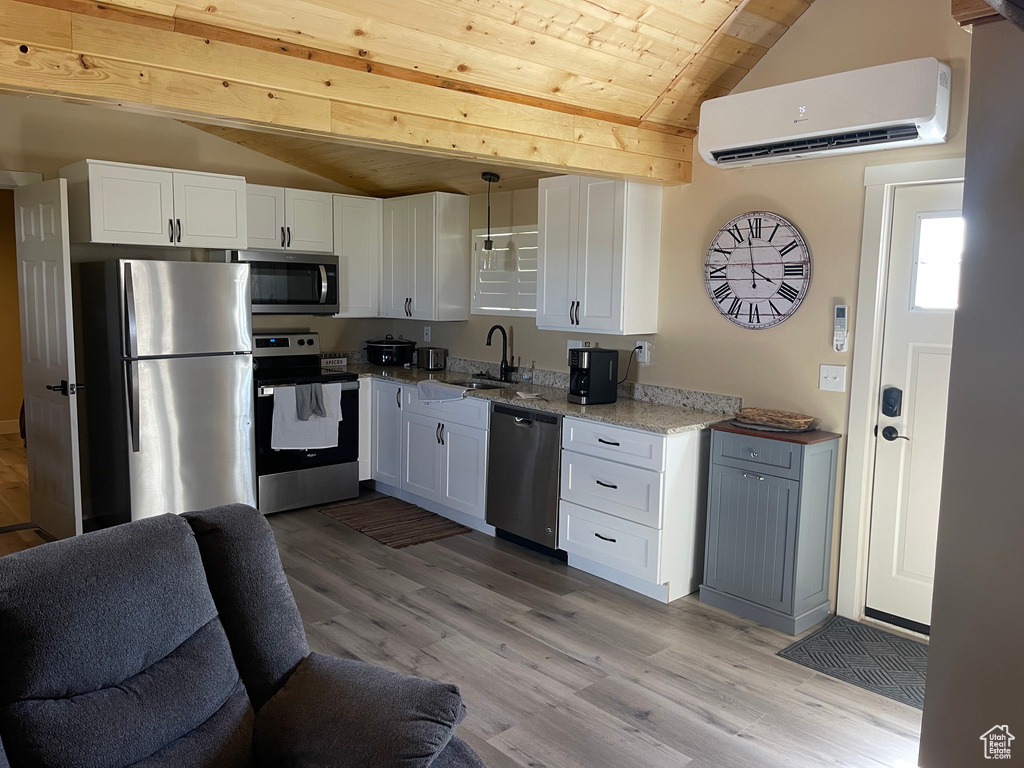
[558,418,708,602]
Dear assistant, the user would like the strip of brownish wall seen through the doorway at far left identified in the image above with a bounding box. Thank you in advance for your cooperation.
[0,189,22,426]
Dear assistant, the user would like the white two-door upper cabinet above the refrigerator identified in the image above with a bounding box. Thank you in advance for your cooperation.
[60,160,247,249]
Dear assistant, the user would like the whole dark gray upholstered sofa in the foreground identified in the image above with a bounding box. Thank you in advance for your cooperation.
[0,505,483,768]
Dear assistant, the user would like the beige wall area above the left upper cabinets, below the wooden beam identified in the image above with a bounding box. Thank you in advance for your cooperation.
[0,96,354,193]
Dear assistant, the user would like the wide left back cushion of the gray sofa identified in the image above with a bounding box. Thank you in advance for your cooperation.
[0,515,249,766]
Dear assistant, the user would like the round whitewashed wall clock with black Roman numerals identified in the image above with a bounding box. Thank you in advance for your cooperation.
[705,211,811,328]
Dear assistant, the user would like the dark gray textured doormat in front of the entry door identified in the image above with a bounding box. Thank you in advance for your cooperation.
[778,616,928,710]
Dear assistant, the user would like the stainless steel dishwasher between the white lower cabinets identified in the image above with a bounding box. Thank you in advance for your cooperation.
[486,402,562,550]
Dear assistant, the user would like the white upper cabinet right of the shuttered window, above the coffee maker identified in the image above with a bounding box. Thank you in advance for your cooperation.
[537,176,662,335]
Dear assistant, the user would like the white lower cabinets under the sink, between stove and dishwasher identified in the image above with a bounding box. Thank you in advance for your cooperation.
[371,379,490,529]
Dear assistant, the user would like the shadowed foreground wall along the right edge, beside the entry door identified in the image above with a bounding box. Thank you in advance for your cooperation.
[920,22,1024,768]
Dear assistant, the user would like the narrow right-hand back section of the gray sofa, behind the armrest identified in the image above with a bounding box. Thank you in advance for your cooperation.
[182,504,309,710]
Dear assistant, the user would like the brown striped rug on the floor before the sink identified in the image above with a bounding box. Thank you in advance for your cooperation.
[321,497,472,549]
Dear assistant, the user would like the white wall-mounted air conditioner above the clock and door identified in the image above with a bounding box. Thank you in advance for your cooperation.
[697,58,949,168]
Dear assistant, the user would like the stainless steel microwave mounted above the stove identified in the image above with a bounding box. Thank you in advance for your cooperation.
[214,251,338,314]
